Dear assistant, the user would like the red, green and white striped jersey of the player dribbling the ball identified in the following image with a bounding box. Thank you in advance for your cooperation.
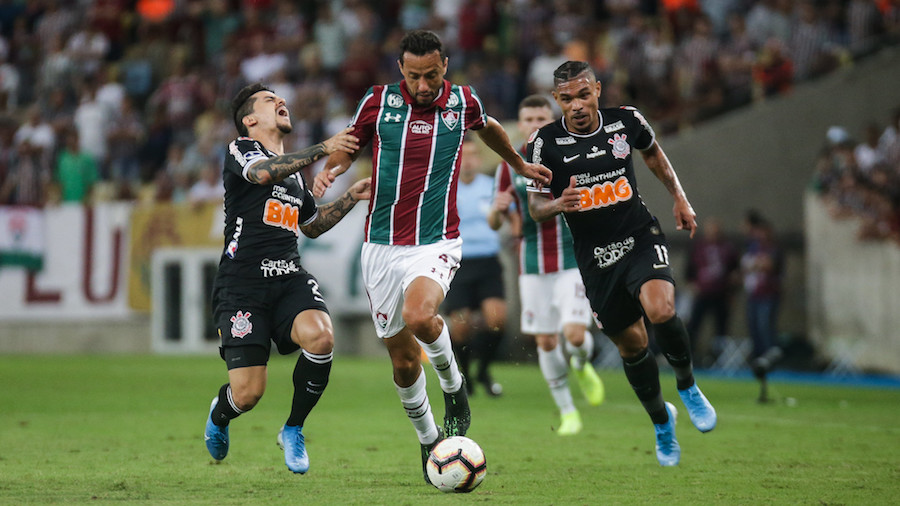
[350,81,487,246]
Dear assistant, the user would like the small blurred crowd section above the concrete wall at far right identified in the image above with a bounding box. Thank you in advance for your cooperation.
[813,107,900,245]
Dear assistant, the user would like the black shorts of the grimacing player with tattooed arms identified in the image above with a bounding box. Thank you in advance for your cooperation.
[212,269,328,369]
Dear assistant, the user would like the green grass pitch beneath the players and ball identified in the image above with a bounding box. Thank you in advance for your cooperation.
[0,356,900,505]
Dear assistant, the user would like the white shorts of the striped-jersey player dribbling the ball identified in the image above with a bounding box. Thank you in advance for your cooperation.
[360,238,462,339]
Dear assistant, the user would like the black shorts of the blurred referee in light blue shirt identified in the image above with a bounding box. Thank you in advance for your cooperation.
[442,256,503,313]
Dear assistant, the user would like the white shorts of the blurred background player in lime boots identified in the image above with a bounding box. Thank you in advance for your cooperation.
[519,269,591,335]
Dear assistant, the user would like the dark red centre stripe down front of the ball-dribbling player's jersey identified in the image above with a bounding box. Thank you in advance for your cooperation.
[392,107,437,244]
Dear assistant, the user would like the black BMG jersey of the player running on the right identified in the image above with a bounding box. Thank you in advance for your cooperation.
[527,107,655,266]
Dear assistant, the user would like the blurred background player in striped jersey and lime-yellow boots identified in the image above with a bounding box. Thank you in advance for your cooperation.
[488,95,603,436]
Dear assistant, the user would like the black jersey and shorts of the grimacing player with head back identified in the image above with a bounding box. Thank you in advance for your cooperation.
[213,137,327,369]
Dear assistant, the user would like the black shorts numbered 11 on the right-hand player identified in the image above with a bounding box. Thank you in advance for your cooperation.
[581,220,675,336]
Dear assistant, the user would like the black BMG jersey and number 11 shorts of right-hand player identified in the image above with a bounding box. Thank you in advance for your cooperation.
[527,107,674,335]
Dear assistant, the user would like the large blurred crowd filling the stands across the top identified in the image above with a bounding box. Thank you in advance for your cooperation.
[0,0,900,207]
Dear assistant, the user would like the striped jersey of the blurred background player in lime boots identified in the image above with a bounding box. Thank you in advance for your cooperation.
[494,157,578,274]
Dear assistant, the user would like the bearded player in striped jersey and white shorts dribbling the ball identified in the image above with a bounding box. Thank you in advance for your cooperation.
[314,30,550,481]
